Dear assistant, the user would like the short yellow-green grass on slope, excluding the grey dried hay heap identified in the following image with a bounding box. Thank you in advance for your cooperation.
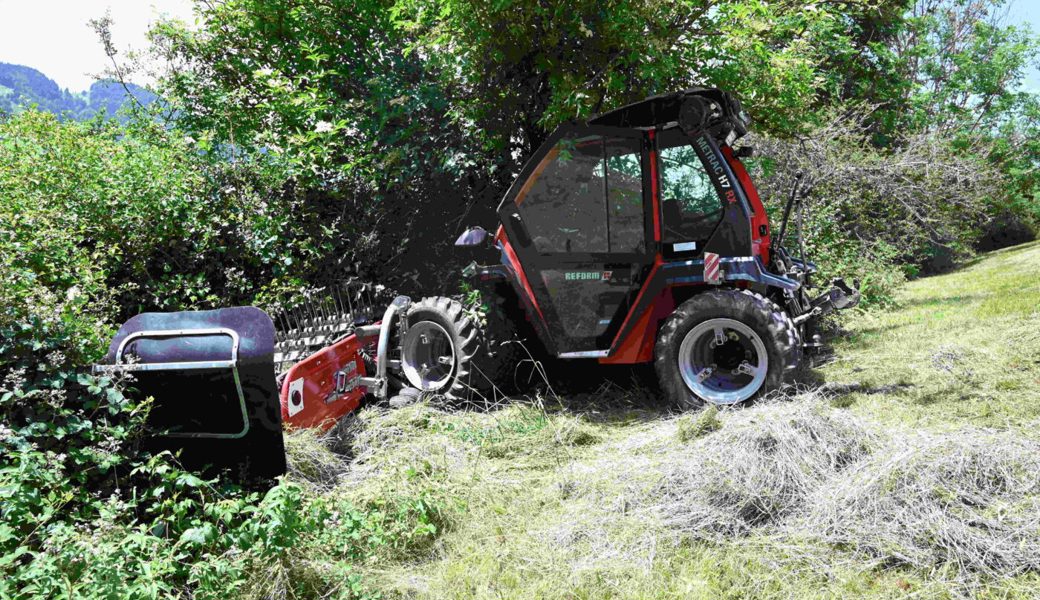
[316,243,1040,598]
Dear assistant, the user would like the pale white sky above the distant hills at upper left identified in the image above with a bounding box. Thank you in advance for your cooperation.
[0,0,194,92]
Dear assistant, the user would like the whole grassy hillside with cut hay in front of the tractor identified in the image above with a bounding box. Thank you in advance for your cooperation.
[290,243,1040,598]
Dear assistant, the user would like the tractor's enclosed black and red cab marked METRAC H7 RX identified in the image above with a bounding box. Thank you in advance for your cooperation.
[496,89,769,362]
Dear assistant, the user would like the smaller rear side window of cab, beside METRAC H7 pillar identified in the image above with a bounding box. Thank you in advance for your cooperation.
[658,137,723,251]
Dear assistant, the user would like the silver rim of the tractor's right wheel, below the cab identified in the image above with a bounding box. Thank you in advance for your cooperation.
[678,318,770,405]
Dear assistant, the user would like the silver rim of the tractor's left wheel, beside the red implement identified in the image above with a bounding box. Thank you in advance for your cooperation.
[400,321,456,392]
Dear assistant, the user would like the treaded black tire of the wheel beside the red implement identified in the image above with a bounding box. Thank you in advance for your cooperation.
[402,296,479,399]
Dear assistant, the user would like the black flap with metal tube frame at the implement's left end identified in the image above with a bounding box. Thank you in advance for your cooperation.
[95,307,285,485]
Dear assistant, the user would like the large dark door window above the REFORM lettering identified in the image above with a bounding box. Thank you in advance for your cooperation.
[517,132,645,254]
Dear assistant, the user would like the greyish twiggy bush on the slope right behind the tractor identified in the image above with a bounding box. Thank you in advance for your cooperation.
[749,109,1007,307]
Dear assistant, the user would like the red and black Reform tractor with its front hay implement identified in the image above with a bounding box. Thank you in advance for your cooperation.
[97,88,859,474]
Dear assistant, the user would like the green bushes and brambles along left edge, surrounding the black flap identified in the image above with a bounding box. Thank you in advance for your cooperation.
[0,111,455,598]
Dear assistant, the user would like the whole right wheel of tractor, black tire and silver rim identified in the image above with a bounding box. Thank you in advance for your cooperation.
[654,289,802,408]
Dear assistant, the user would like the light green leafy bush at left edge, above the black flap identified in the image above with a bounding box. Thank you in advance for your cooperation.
[0,111,314,317]
